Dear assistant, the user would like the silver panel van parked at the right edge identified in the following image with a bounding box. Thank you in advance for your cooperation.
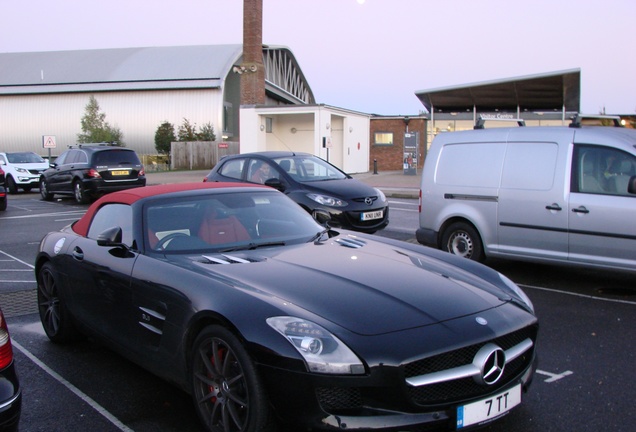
[416,119,636,271]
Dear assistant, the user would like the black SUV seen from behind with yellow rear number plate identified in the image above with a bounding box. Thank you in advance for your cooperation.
[40,144,146,204]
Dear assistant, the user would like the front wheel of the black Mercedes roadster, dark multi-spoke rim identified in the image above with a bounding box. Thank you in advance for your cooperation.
[190,326,272,432]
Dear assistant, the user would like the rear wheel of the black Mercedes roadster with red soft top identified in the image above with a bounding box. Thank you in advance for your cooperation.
[38,263,81,343]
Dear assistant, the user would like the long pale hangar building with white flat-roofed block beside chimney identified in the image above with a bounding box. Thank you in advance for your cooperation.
[0,44,370,172]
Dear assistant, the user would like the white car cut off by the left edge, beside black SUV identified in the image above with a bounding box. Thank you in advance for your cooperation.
[0,152,49,194]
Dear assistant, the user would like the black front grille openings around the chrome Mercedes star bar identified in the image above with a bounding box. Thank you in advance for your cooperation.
[404,326,537,405]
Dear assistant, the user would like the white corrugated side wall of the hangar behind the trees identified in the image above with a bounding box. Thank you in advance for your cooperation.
[0,89,223,156]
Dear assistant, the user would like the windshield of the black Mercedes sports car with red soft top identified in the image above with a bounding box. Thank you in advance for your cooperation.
[144,189,323,253]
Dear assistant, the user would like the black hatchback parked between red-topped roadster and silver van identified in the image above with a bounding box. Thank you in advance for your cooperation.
[203,151,389,233]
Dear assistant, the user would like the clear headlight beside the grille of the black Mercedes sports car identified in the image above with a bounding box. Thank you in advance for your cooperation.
[267,316,364,375]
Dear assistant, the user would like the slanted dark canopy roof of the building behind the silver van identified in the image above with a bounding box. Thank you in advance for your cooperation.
[415,69,581,113]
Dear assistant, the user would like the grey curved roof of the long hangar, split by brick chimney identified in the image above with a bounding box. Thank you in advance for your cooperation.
[0,44,315,104]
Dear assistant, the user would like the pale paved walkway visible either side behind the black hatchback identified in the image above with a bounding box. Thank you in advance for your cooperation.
[146,170,421,199]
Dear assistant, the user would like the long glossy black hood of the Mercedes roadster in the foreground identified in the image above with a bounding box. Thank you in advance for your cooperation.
[180,236,510,335]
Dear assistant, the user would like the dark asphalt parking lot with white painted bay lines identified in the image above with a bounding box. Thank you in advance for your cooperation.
[0,186,636,432]
